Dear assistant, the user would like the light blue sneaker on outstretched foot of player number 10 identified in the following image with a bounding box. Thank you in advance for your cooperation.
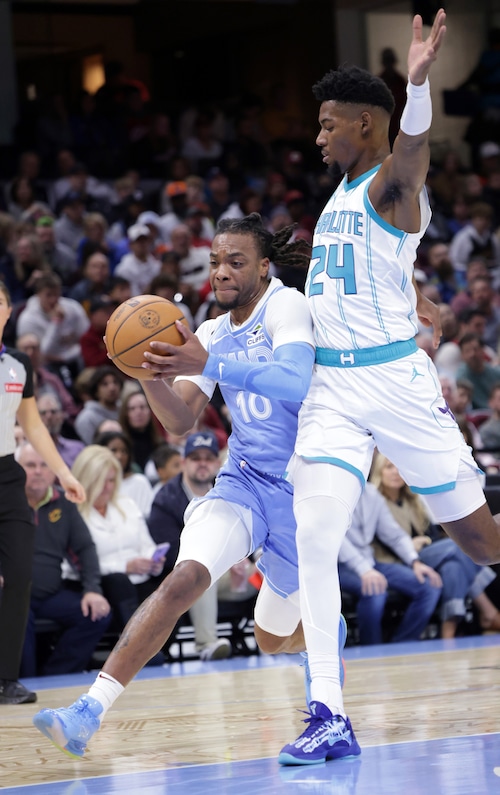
[33,695,102,757]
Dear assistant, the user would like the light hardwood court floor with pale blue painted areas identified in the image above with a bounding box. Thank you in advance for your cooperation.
[0,635,500,795]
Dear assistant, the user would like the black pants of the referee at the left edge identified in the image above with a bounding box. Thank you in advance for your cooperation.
[0,456,35,679]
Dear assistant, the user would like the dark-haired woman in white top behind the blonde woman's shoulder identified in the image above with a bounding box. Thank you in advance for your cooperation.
[94,430,154,519]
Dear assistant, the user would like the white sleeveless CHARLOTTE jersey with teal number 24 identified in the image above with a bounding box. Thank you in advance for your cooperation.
[305,166,431,350]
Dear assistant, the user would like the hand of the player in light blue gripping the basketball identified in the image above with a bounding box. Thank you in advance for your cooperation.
[142,321,208,378]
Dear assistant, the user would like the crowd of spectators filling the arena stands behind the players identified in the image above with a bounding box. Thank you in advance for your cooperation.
[0,57,500,673]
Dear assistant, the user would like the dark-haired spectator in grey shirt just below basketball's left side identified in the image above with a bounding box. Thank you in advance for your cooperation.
[75,364,123,444]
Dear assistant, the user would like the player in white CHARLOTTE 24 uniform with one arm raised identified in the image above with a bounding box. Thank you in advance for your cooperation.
[279,9,500,764]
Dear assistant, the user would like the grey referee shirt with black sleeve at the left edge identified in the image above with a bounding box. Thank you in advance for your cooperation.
[0,345,34,457]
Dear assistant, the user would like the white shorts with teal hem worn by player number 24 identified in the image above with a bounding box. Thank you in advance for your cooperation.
[295,349,484,521]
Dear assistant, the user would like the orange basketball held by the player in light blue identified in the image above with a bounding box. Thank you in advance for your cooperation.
[106,295,188,381]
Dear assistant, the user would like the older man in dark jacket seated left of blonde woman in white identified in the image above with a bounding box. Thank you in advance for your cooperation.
[16,443,111,676]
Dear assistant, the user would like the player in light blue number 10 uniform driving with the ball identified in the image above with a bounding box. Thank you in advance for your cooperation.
[34,213,345,756]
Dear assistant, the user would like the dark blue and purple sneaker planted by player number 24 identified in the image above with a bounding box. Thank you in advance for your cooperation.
[278,701,361,765]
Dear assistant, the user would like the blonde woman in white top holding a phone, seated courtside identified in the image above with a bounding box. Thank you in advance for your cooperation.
[73,444,165,665]
